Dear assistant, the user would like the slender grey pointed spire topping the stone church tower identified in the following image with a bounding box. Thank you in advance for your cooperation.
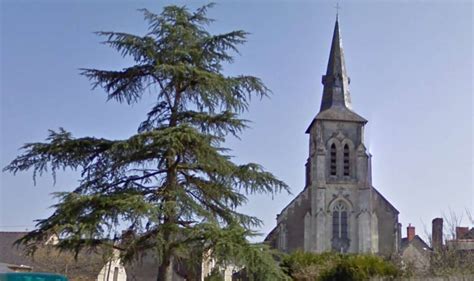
[320,18,352,111]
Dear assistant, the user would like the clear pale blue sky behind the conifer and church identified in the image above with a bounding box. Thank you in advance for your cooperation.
[0,0,474,241]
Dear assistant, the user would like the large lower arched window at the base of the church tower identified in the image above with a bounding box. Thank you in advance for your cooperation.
[332,201,350,253]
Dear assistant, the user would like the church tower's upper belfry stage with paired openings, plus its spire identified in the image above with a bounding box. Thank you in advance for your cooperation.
[306,20,370,187]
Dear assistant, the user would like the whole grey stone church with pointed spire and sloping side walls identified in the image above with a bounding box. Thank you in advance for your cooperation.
[265,19,401,255]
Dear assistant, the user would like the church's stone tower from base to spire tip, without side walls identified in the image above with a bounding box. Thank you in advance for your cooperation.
[306,20,378,252]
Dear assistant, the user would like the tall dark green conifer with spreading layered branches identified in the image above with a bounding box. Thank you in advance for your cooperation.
[4,5,288,281]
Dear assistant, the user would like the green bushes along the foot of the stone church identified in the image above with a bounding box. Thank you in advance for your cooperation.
[282,251,401,281]
